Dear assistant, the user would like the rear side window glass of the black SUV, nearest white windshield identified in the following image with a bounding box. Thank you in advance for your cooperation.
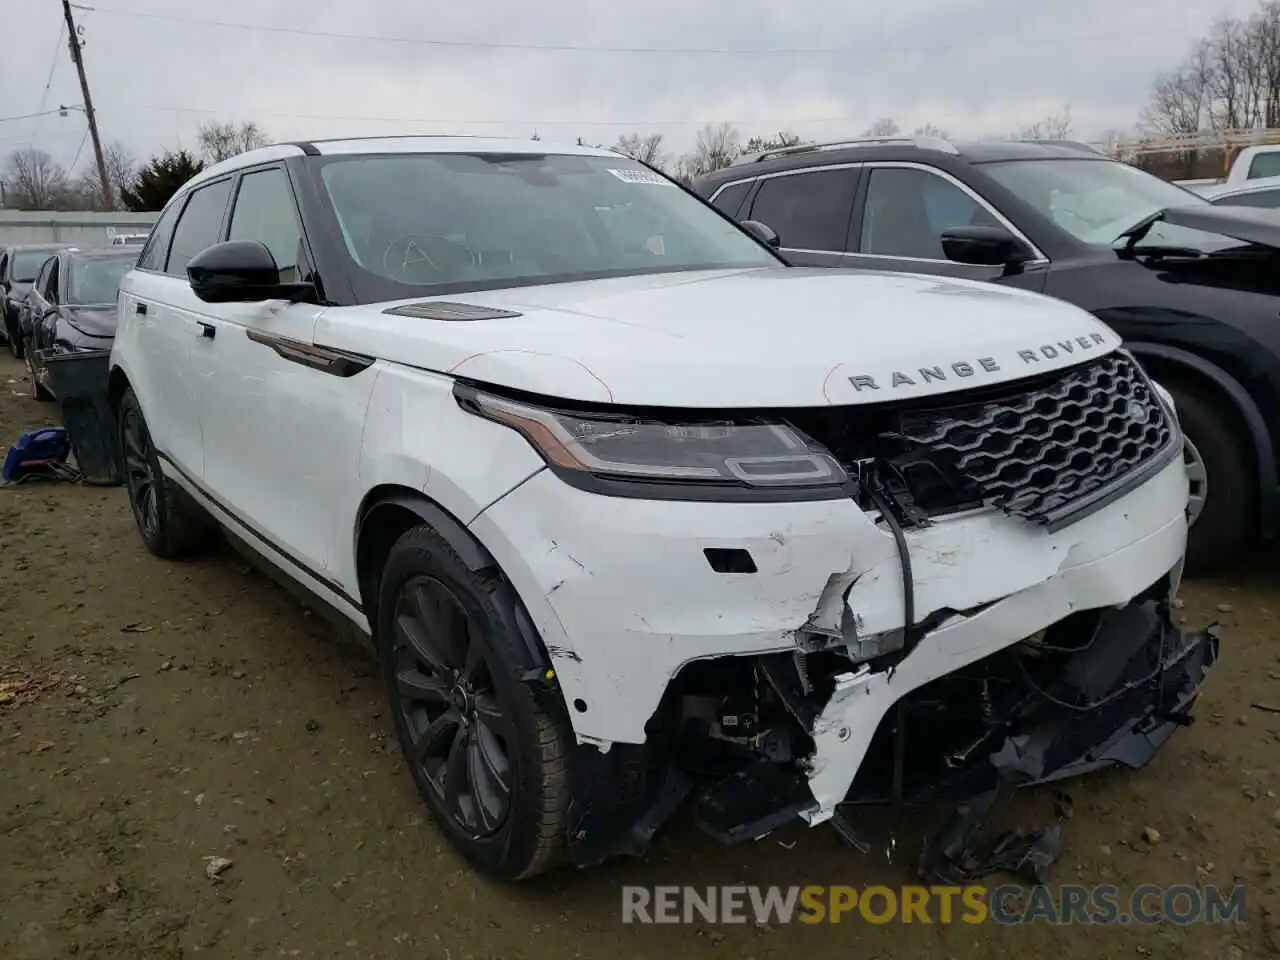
[751,169,858,253]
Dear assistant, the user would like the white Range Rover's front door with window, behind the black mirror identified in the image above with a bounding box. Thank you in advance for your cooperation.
[194,166,374,594]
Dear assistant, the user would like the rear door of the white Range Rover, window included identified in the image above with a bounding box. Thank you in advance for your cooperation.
[119,177,232,483]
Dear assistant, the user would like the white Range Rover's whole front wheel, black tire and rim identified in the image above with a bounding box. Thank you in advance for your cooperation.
[375,526,572,879]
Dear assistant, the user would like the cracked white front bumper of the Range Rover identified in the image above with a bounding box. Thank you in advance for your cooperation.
[471,461,1212,859]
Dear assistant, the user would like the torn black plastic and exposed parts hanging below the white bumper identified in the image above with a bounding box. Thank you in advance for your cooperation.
[570,577,1219,883]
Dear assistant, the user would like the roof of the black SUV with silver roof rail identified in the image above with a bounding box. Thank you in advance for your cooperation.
[698,137,1110,192]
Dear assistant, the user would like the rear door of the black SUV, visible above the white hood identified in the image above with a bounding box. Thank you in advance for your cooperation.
[742,164,860,266]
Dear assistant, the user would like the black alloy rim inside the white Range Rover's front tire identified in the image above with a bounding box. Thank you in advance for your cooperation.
[392,576,516,837]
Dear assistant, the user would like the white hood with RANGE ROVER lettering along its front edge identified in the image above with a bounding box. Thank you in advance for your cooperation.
[315,268,1120,408]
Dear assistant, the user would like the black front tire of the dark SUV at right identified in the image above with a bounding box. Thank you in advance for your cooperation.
[1169,384,1257,575]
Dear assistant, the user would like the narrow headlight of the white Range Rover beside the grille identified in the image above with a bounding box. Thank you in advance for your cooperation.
[456,385,847,499]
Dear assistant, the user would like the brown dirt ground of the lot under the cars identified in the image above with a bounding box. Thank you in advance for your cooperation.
[0,356,1280,960]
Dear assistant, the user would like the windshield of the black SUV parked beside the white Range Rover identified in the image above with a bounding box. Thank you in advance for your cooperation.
[984,159,1239,251]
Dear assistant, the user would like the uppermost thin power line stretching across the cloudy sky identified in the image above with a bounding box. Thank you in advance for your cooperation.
[82,6,1183,56]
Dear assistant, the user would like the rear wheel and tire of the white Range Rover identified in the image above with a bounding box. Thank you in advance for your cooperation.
[116,389,218,559]
